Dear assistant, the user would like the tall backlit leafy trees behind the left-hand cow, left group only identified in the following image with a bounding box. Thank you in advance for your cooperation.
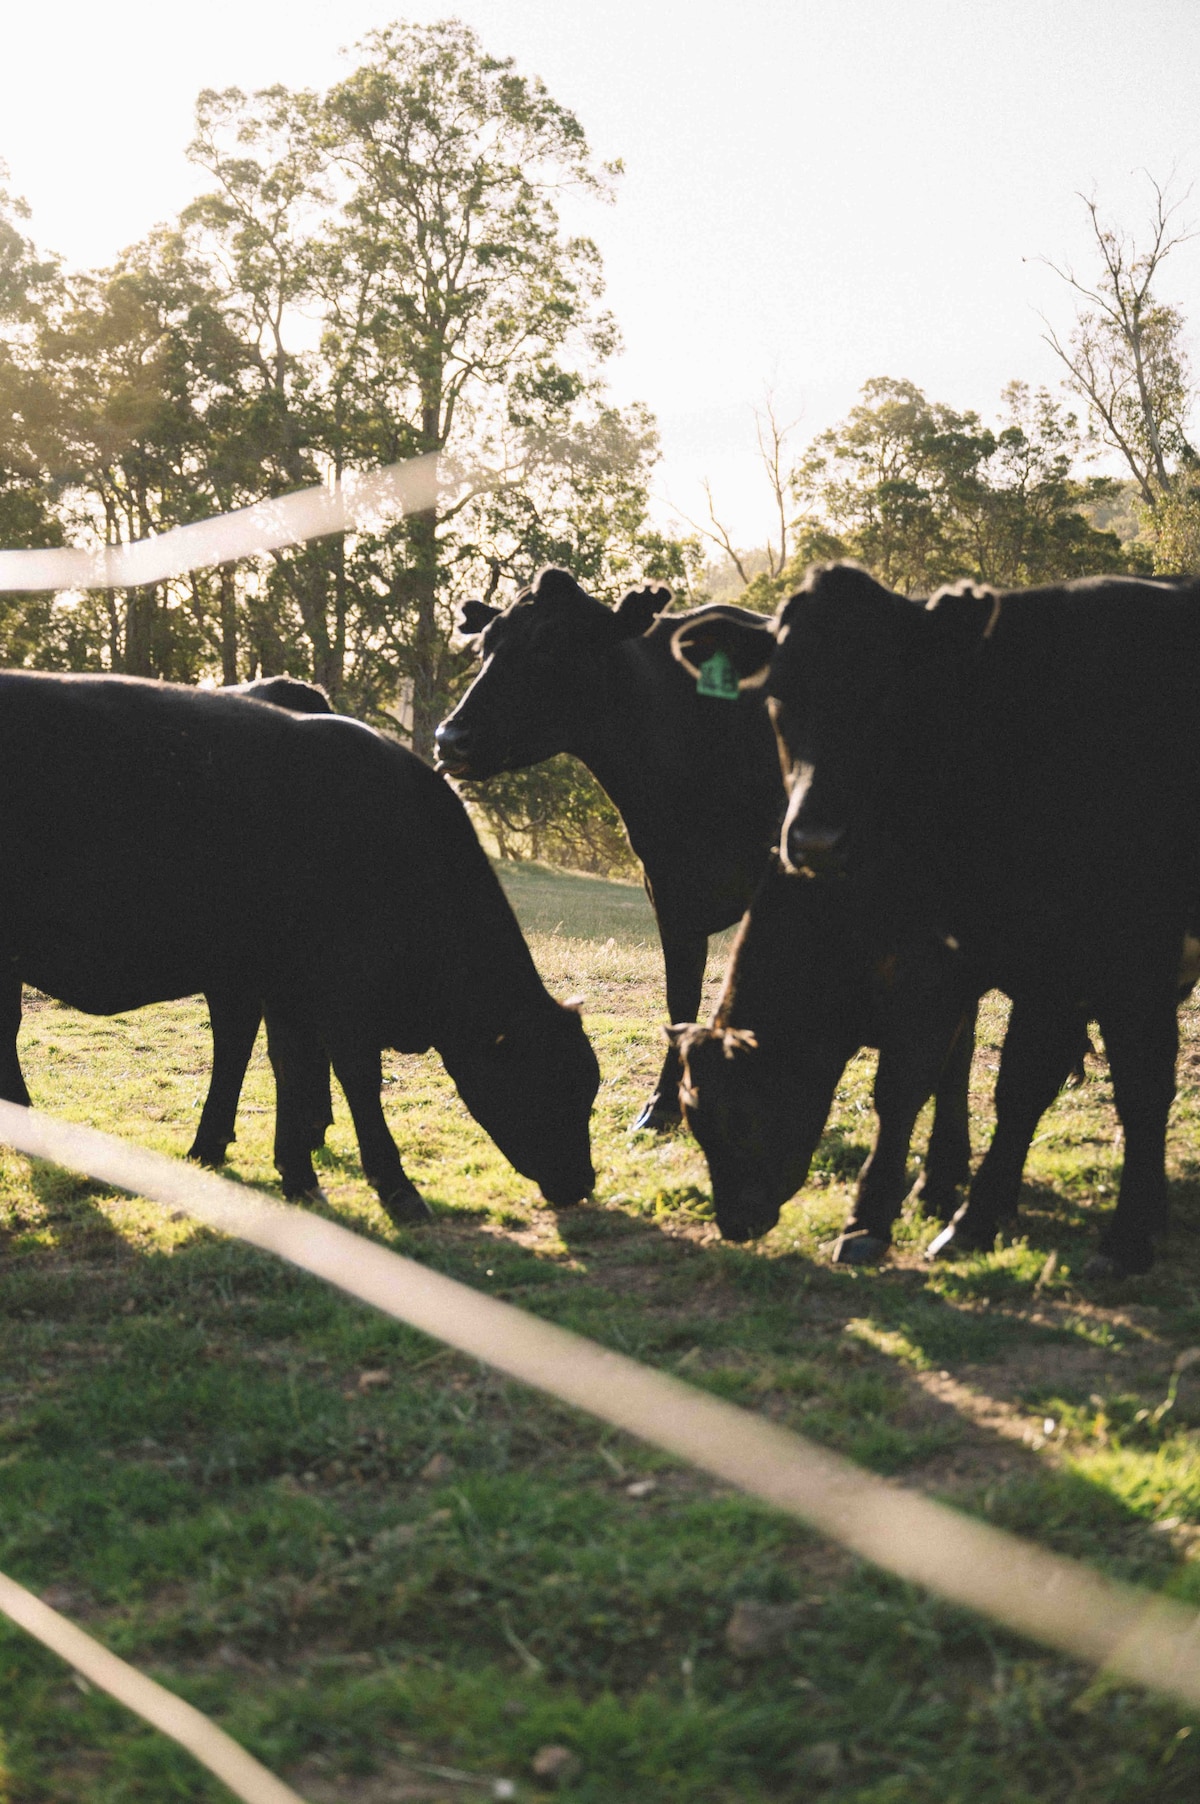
[0,22,682,754]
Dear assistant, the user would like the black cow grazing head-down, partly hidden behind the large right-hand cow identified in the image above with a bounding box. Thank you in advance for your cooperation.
[671,868,974,1265]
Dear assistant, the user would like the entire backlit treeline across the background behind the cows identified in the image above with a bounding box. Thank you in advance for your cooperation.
[0,20,1200,870]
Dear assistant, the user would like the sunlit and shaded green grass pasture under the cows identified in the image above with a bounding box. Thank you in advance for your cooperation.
[0,868,1200,1804]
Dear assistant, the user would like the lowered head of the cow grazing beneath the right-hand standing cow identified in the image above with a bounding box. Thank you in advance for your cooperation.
[668,1026,846,1241]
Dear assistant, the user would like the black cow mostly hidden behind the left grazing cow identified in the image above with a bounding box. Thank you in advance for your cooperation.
[0,677,334,1165]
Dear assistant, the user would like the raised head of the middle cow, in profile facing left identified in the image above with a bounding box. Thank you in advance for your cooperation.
[435,566,671,779]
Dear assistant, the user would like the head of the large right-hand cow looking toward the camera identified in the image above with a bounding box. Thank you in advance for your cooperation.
[767,565,1000,875]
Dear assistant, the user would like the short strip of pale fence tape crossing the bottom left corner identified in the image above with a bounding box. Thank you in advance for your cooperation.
[0,1573,305,1804]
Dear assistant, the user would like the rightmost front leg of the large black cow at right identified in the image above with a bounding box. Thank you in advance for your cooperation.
[1085,998,1178,1277]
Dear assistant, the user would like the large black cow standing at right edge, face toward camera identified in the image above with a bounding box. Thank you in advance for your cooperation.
[750,565,1200,1275]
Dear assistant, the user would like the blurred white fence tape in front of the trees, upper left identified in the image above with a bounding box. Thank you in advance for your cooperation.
[0,455,438,590]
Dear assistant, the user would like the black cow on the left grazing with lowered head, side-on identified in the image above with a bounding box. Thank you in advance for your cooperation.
[0,673,599,1221]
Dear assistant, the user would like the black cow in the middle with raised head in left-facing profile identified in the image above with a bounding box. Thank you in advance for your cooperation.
[437,568,783,1128]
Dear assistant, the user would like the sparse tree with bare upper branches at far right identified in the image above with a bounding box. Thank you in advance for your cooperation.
[1045,177,1196,520]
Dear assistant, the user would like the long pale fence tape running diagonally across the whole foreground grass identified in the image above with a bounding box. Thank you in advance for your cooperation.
[0,1102,1200,1707]
